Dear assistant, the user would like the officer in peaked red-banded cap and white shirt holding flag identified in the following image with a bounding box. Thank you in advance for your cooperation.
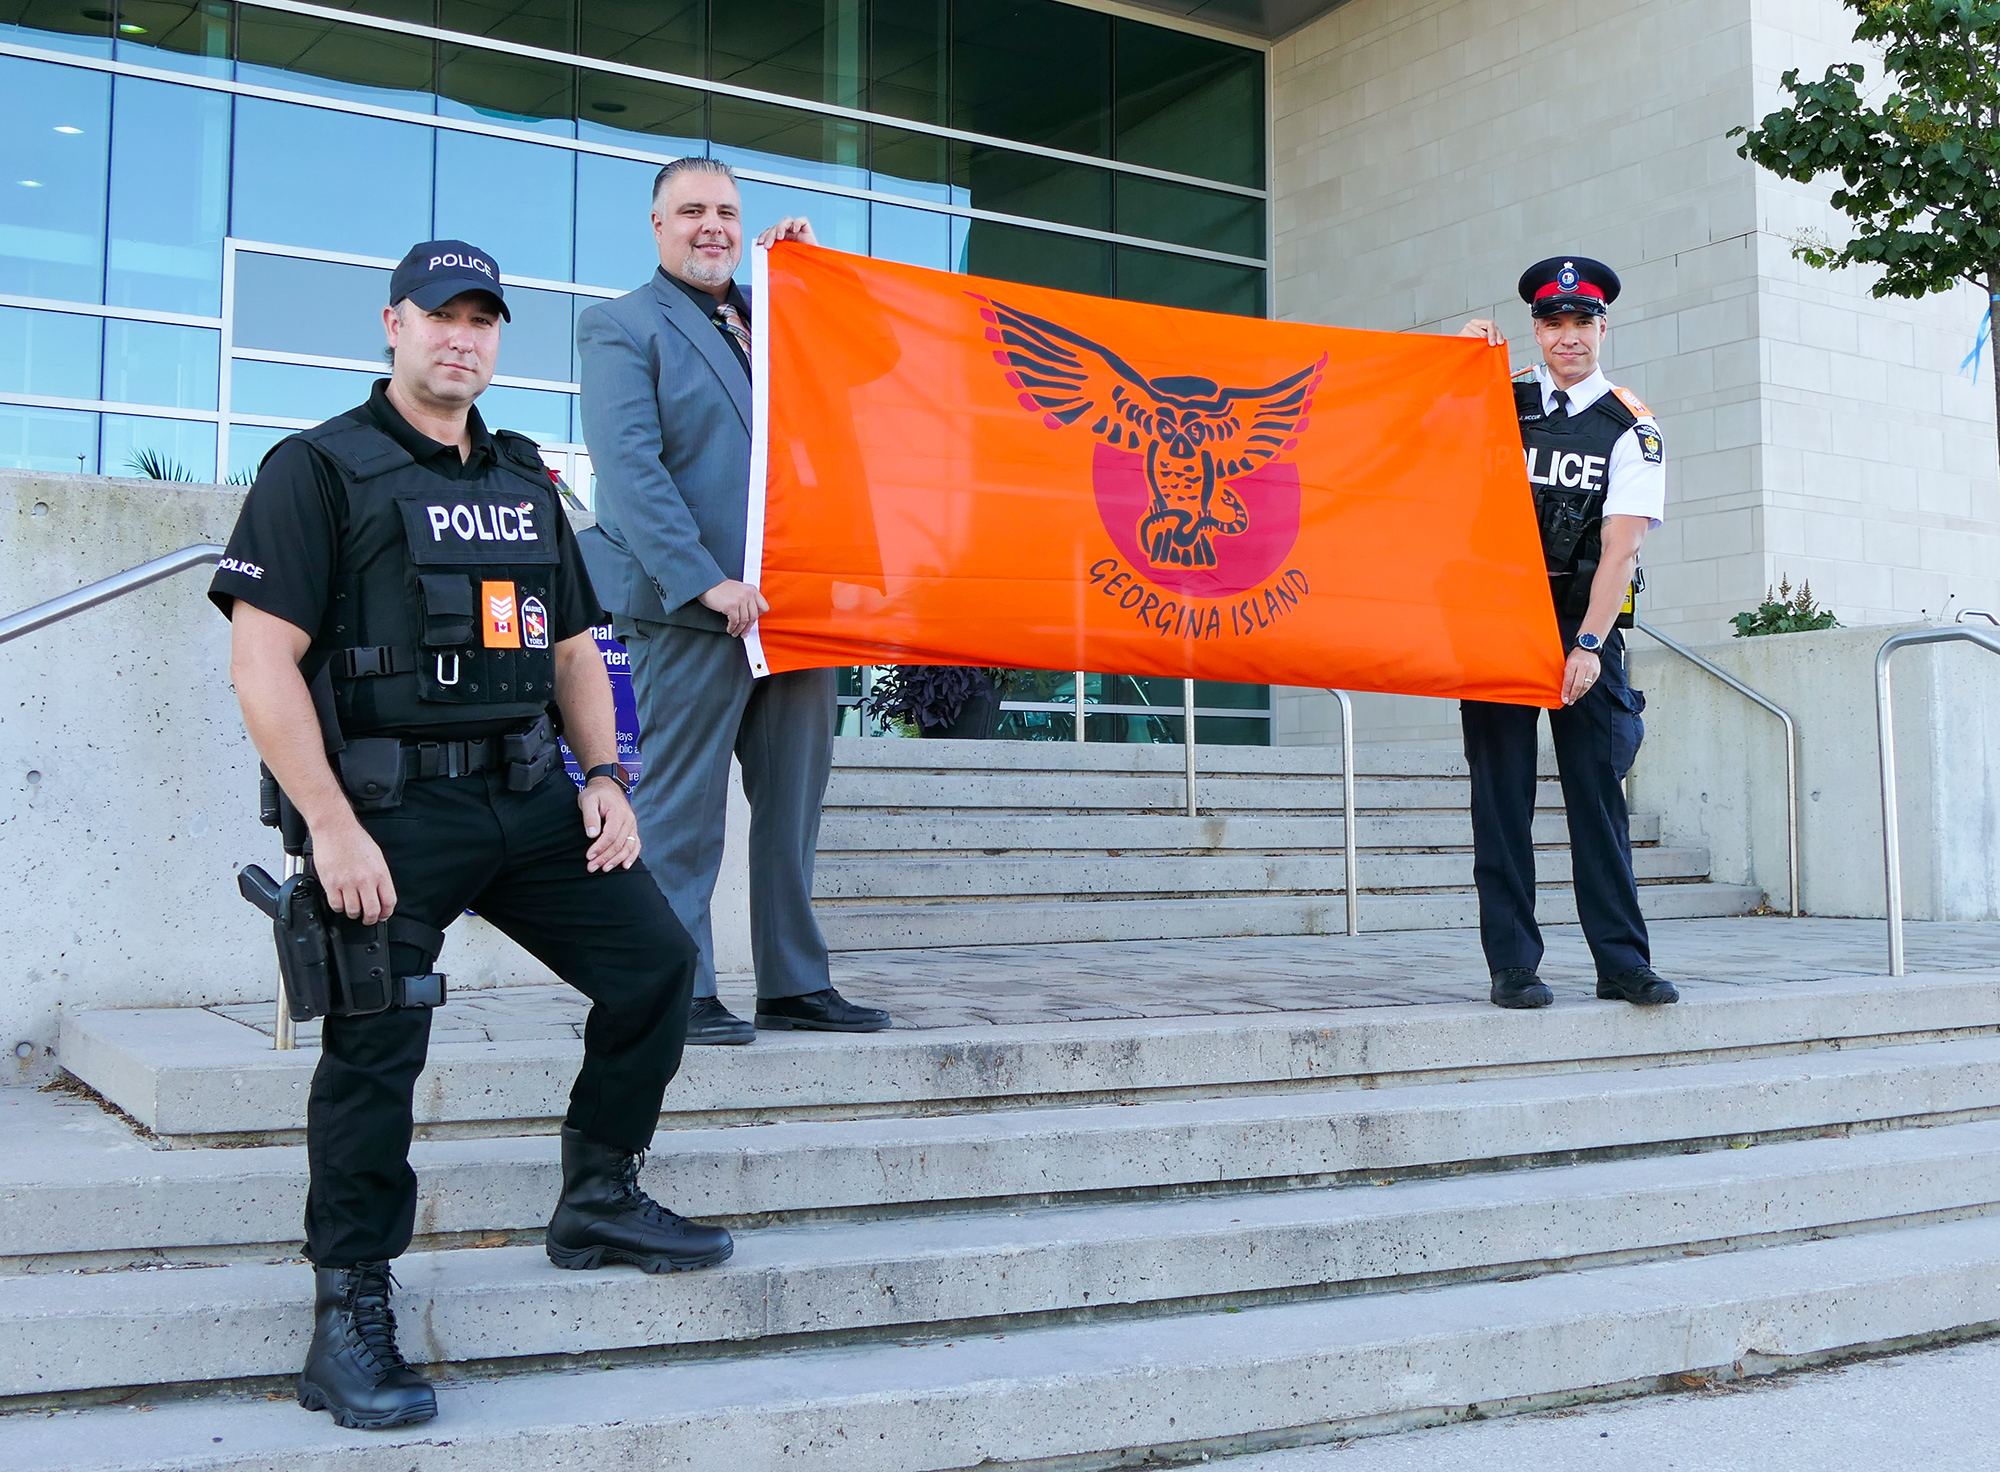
[1460,256,1680,1008]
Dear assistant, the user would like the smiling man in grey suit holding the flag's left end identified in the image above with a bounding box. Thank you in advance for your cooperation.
[576,158,888,1044]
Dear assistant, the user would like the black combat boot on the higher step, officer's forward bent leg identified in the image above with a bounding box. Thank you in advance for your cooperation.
[548,1126,736,1272]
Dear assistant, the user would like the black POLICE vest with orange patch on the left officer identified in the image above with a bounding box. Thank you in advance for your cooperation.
[298,418,562,738]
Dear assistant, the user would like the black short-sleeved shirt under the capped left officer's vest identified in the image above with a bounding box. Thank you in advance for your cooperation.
[208,378,610,736]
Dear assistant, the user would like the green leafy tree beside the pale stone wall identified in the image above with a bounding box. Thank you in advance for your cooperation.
[1730,0,2000,460]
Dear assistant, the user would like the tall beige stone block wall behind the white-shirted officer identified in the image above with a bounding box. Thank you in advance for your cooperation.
[1272,0,2000,738]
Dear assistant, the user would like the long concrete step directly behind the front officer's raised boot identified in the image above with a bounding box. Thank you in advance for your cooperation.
[23,1014,2000,1272]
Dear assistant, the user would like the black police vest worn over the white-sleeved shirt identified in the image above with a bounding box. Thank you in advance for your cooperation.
[1514,378,1638,618]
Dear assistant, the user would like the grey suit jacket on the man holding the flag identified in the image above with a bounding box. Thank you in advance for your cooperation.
[576,272,750,630]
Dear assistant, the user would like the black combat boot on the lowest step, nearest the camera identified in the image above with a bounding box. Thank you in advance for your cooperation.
[298,1262,438,1430]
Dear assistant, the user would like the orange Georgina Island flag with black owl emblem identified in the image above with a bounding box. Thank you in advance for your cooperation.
[744,244,1562,706]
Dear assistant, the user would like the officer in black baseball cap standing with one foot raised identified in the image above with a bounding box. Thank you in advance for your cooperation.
[210,240,732,1428]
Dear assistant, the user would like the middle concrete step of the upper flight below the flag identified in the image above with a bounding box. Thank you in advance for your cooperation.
[820,810,1660,866]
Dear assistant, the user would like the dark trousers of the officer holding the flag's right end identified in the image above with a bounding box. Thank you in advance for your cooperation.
[1458,618,1652,976]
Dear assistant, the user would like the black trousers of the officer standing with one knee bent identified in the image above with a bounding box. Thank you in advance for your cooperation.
[306,768,696,1268]
